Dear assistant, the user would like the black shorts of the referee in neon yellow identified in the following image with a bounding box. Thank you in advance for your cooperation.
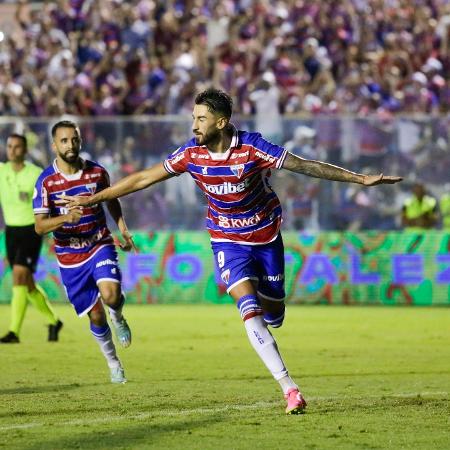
[5,225,42,273]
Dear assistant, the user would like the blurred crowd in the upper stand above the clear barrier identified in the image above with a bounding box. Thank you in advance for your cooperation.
[0,0,450,117]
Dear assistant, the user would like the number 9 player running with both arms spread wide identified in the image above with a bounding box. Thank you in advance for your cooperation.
[62,89,401,414]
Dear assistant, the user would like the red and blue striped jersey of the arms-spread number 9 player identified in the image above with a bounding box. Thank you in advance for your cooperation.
[164,130,287,245]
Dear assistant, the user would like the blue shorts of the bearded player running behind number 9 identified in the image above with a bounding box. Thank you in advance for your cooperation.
[60,245,122,316]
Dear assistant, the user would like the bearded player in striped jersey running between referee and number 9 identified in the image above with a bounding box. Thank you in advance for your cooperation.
[33,121,133,383]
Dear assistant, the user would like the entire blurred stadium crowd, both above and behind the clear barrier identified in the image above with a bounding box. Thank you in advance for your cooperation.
[0,0,450,231]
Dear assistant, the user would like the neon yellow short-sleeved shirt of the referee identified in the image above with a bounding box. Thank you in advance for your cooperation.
[0,161,42,227]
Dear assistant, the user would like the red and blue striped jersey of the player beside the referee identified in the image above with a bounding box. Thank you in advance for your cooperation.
[33,160,113,267]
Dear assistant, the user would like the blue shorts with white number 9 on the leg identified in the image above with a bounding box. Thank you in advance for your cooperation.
[211,234,286,301]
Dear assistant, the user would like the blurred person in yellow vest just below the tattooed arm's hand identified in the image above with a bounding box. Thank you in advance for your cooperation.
[402,183,438,231]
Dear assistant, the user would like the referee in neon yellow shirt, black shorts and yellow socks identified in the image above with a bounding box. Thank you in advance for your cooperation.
[0,133,63,344]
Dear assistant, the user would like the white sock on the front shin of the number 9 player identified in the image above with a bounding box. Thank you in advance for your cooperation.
[244,316,289,381]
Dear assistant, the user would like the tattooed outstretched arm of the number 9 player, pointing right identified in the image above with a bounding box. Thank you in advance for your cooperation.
[283,152,402,186]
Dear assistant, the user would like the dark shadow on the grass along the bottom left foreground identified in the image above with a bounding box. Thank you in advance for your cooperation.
[23,415,224,450]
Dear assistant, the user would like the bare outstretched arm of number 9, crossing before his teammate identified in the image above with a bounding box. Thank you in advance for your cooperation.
[58,162,173,207]
